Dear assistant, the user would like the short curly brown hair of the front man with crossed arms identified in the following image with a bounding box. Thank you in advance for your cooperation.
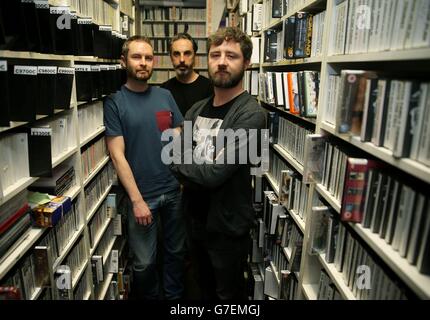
[208,27,252,60]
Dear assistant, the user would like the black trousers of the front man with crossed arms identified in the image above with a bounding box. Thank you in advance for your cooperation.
[191,221,250,301]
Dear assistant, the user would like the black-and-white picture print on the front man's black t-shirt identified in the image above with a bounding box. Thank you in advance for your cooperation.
[193,116,223,163]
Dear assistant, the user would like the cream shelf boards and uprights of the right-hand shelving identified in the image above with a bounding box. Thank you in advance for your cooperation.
[248,0,430,300]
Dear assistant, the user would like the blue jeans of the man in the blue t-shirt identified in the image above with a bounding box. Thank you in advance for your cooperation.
[128,189,185,299]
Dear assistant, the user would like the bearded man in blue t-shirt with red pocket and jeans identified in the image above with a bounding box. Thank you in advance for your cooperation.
[104,36,185,299]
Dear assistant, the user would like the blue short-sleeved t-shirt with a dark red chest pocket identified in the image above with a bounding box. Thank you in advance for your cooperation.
[104,85,184,198]
